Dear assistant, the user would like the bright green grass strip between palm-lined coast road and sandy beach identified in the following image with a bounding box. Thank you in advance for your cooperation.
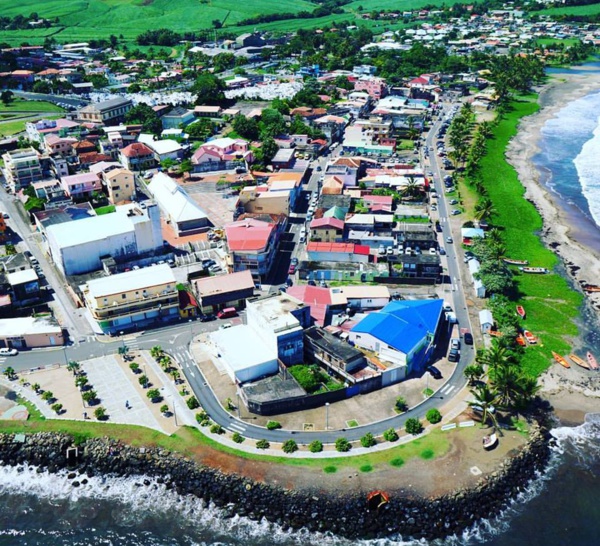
[481,95,582,376]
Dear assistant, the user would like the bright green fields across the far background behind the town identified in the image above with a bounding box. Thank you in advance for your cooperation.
[0,0,476,45]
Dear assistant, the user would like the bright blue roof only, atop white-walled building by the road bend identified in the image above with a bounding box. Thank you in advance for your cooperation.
[352,300,444,354]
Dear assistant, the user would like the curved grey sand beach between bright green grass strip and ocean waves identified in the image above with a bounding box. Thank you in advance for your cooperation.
[506,71,600,318]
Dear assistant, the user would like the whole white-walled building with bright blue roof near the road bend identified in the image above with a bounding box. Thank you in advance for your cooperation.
[349,299,444,386]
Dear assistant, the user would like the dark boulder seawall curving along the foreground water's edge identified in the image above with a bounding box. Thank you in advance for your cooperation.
[0,418,552,540]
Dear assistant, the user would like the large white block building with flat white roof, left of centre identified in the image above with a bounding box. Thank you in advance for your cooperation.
[46,203,163,275]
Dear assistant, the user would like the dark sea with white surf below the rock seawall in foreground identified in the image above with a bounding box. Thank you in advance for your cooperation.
[0,414,600,546]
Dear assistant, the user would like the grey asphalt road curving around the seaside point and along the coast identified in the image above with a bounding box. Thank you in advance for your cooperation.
[3,101,475,444]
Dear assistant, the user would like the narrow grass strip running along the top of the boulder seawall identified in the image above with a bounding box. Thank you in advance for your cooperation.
[0,418,450,472]
